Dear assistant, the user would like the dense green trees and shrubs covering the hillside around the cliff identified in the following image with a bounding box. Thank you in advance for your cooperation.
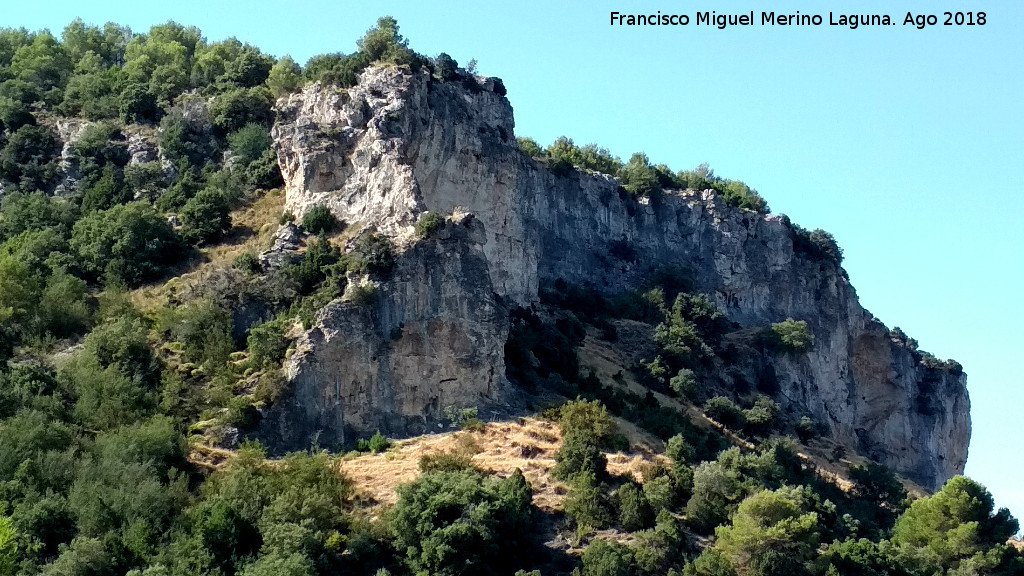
[0,14,1007,576]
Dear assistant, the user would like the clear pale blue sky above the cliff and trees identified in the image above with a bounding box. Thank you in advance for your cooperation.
[9,0,1024,518]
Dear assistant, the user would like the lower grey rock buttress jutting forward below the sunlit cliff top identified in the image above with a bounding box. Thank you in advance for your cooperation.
[262,216,514,449]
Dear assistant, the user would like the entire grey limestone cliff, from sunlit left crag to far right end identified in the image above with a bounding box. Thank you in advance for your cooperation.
[268,68,971,489]
